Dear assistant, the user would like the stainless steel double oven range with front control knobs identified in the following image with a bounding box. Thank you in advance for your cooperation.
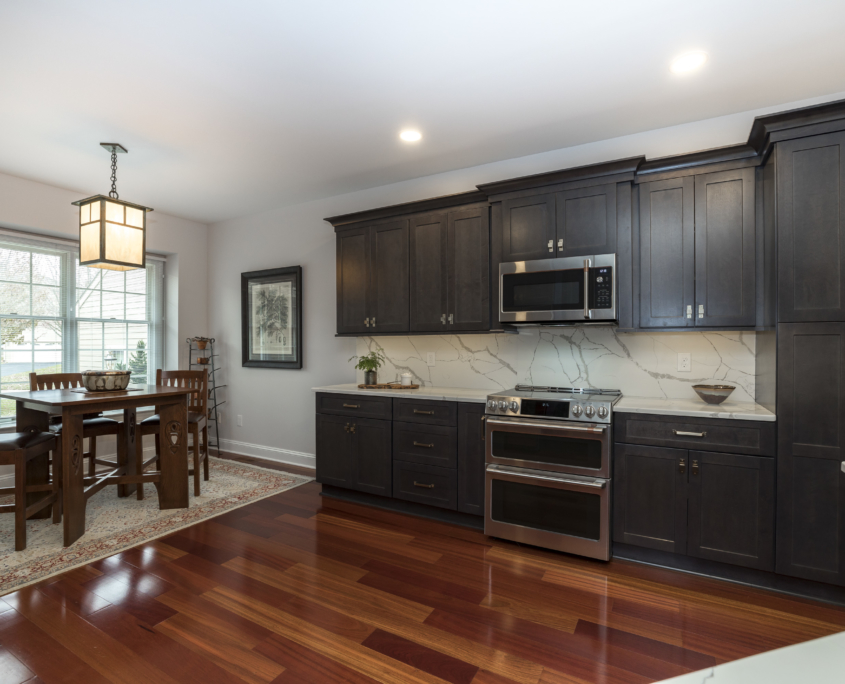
[484,385,621,560]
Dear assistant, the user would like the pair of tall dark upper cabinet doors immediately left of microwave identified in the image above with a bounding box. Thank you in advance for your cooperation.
[410,205,490,332]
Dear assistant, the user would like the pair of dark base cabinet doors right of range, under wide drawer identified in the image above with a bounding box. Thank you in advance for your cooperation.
[613,436,775,571]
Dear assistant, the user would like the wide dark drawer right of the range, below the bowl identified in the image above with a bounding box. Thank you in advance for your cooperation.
[614,413,775,456]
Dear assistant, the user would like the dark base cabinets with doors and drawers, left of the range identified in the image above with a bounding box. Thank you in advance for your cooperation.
[317,393,484,515]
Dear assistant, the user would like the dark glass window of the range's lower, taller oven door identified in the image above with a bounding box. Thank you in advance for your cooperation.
[491,480,601,540]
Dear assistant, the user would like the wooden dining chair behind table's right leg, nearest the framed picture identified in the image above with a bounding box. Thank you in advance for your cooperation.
[135,368,208,499]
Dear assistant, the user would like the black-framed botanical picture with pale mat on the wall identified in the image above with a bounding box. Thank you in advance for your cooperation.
[241,266,302,369]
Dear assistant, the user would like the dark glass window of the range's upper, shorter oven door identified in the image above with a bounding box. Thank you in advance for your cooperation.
[492,430,602,470]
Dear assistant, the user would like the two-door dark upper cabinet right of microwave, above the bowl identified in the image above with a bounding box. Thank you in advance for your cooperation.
[639,166,757,328]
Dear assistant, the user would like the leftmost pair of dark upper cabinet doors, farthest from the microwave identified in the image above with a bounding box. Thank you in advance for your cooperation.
[337,219,410,334]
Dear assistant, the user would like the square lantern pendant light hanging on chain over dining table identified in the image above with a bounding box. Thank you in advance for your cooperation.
[73,143,152,271]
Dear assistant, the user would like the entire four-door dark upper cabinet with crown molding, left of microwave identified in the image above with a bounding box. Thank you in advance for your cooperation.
[327,192,490,335]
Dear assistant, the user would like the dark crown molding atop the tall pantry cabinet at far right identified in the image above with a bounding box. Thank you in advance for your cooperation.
[748,100,845,155]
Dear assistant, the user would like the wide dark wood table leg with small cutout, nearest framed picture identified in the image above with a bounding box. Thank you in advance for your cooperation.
[158,397,188,510]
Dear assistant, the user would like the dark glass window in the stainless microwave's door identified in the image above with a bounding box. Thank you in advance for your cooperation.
[502,269,584,311]
